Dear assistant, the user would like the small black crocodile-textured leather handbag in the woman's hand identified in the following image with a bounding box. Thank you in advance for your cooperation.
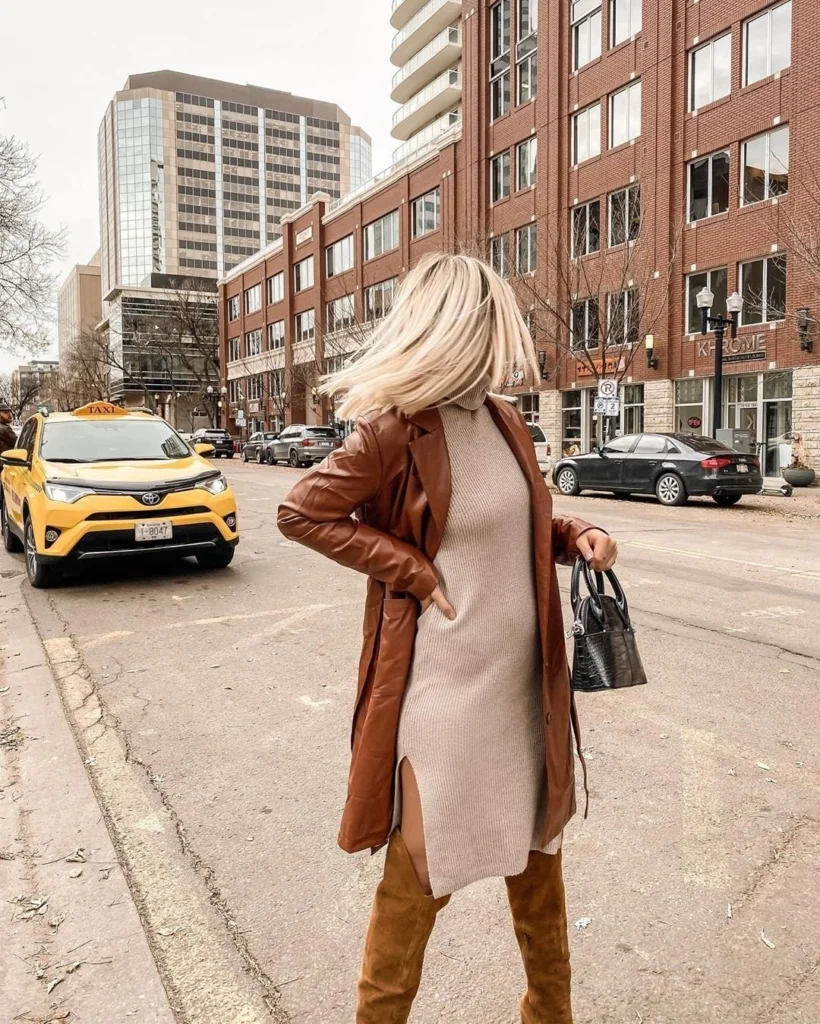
[567,558,646,691]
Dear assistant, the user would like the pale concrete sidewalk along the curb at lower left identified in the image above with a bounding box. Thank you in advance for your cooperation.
[0,563,174,1024]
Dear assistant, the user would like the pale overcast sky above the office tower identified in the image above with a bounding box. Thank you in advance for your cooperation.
[0,0,395,370]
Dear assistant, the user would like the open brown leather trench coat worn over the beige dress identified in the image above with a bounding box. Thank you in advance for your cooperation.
[278,397,593,853]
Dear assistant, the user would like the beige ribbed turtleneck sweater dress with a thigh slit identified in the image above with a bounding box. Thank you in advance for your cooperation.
[395,391,561,896]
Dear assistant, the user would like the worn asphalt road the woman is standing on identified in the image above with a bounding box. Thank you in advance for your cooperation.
[11,462,820,1024]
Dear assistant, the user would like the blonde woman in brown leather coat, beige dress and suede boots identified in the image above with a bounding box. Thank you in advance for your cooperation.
[278,249,616,1024]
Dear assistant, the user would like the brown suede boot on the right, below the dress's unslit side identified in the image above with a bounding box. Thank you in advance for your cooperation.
[505,850,572,1024]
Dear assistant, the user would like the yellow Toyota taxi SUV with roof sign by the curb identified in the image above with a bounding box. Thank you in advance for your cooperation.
[0,401,239,587]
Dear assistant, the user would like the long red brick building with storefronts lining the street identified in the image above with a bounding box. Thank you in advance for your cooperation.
[220,0,820,474]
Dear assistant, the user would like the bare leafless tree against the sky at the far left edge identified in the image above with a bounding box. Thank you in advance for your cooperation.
[0,135,63,352]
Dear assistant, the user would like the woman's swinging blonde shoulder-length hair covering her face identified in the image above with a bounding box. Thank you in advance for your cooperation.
[320,253,538,419]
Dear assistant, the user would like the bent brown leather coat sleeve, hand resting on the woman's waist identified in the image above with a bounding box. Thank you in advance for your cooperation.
[277,420,438,601]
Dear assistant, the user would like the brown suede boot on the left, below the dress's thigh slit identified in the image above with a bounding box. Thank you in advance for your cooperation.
[356,830,449,1024]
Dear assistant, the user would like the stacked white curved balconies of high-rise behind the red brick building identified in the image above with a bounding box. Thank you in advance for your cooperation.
[390,0,462,161]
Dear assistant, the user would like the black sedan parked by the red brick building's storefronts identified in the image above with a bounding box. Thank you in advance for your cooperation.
[553,434,763,505]
